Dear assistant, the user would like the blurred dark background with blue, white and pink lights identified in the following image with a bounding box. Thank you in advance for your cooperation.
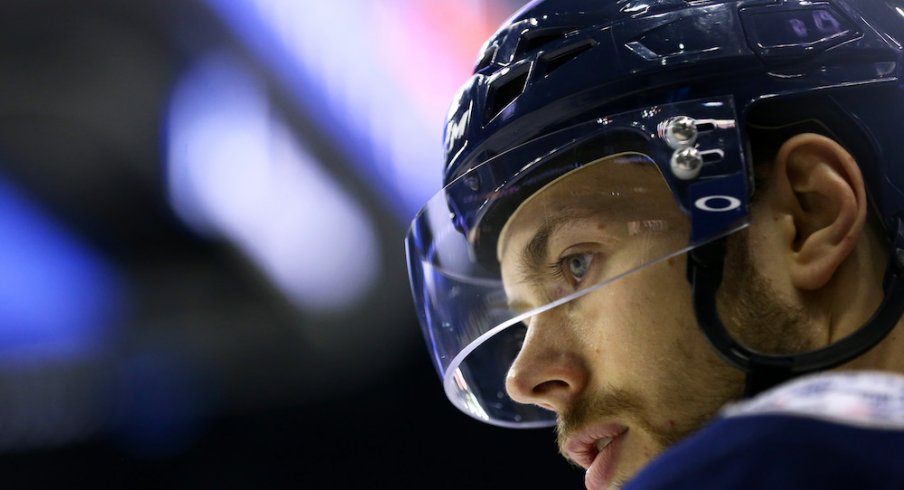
[0,0,583,489]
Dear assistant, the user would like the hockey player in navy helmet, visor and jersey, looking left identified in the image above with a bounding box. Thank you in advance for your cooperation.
[406,0,904,490]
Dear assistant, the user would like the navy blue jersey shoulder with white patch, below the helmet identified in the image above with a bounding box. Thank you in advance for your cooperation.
[625,372,904,490]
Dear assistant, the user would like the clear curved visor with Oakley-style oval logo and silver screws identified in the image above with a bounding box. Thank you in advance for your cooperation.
[406,97,747,427]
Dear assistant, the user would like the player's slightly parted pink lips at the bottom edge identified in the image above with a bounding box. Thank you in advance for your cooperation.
[564,424,628,490]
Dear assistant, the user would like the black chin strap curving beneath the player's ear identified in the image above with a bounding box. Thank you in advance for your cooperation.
[687,217,904,397]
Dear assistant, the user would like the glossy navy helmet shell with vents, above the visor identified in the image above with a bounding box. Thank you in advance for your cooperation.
[444,0,904,242]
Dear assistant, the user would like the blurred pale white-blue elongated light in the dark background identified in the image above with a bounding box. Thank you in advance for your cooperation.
[167,55,381,313]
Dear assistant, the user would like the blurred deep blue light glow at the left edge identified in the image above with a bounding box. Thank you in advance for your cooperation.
[0,170,122,366]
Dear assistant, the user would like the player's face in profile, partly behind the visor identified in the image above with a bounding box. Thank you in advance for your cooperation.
[499,160,743,490]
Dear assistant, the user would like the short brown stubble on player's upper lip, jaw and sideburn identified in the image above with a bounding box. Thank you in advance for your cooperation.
[557,230,810,480]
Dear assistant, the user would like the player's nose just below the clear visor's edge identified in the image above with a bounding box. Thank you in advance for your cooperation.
[505,317,589,413]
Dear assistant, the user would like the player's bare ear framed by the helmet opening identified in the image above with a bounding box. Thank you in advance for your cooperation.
[773,133,868,290]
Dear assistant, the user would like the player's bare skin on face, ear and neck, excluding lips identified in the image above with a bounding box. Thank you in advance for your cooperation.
[498,134,904,486]
